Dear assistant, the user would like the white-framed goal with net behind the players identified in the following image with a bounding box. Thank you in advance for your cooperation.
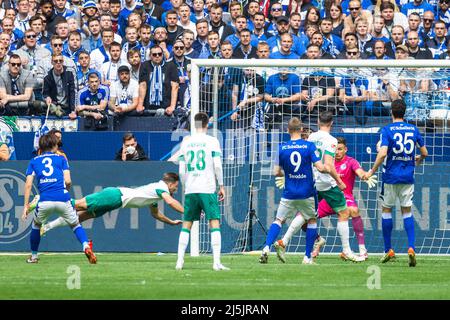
[191,59,450,254]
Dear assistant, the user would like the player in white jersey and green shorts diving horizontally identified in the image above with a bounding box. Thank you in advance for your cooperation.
[34,172,184,236]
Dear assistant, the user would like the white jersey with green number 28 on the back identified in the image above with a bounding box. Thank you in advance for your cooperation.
[178,133,222,194]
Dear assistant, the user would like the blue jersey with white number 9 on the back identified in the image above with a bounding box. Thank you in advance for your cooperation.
[278,139,320,200]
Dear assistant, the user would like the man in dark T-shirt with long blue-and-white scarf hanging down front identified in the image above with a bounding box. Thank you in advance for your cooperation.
[136,45,180,116]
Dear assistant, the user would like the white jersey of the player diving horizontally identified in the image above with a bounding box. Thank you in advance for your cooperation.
[118,180,169,208]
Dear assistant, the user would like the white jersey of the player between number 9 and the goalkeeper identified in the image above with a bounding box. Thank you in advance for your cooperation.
[308,130,337,191]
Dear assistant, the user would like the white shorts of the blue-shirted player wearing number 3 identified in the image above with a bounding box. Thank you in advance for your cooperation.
[34,201,79,226]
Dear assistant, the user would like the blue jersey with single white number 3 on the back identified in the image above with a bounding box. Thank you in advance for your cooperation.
[26,152,70,202]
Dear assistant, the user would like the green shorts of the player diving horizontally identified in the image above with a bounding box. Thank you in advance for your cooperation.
[86,187,122,218]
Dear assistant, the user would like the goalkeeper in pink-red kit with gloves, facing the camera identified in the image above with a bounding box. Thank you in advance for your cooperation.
[275,137,378,262]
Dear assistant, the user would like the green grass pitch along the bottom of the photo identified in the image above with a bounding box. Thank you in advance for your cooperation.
[0,253,450,300]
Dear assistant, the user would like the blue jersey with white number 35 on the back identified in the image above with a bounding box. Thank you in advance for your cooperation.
[380,122,424,184]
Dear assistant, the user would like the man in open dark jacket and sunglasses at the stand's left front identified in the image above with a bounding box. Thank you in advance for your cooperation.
[42,53,77,119]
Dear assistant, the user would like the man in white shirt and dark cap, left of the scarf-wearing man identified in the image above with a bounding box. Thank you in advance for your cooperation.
[109,65,139,116]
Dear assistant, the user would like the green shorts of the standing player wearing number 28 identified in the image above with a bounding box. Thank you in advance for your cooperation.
[183,193,220,221]
